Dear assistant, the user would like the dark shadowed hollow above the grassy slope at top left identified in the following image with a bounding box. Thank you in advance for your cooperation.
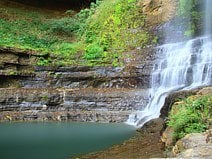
[9,0,96,11]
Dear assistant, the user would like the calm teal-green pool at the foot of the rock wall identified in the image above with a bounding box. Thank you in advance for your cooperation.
[0,122,135,159]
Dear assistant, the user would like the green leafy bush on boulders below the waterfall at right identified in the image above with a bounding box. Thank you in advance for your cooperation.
[168,95,212,140]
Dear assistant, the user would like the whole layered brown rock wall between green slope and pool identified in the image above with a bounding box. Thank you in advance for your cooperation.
[0,44,152,122]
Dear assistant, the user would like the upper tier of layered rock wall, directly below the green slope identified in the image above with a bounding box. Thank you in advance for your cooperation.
[0,48,152,88]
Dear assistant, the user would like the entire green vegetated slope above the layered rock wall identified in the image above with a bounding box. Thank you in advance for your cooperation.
[0,0,154,66]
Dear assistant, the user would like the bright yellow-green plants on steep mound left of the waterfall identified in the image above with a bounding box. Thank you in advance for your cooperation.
[80,0,151,65]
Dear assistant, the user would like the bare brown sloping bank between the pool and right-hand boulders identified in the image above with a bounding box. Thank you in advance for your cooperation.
[74,118,165,159]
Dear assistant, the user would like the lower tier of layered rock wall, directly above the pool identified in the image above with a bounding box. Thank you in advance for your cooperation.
[0,88,147,122]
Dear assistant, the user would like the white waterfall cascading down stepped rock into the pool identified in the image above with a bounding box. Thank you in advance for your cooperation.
[127,0,212,127]
